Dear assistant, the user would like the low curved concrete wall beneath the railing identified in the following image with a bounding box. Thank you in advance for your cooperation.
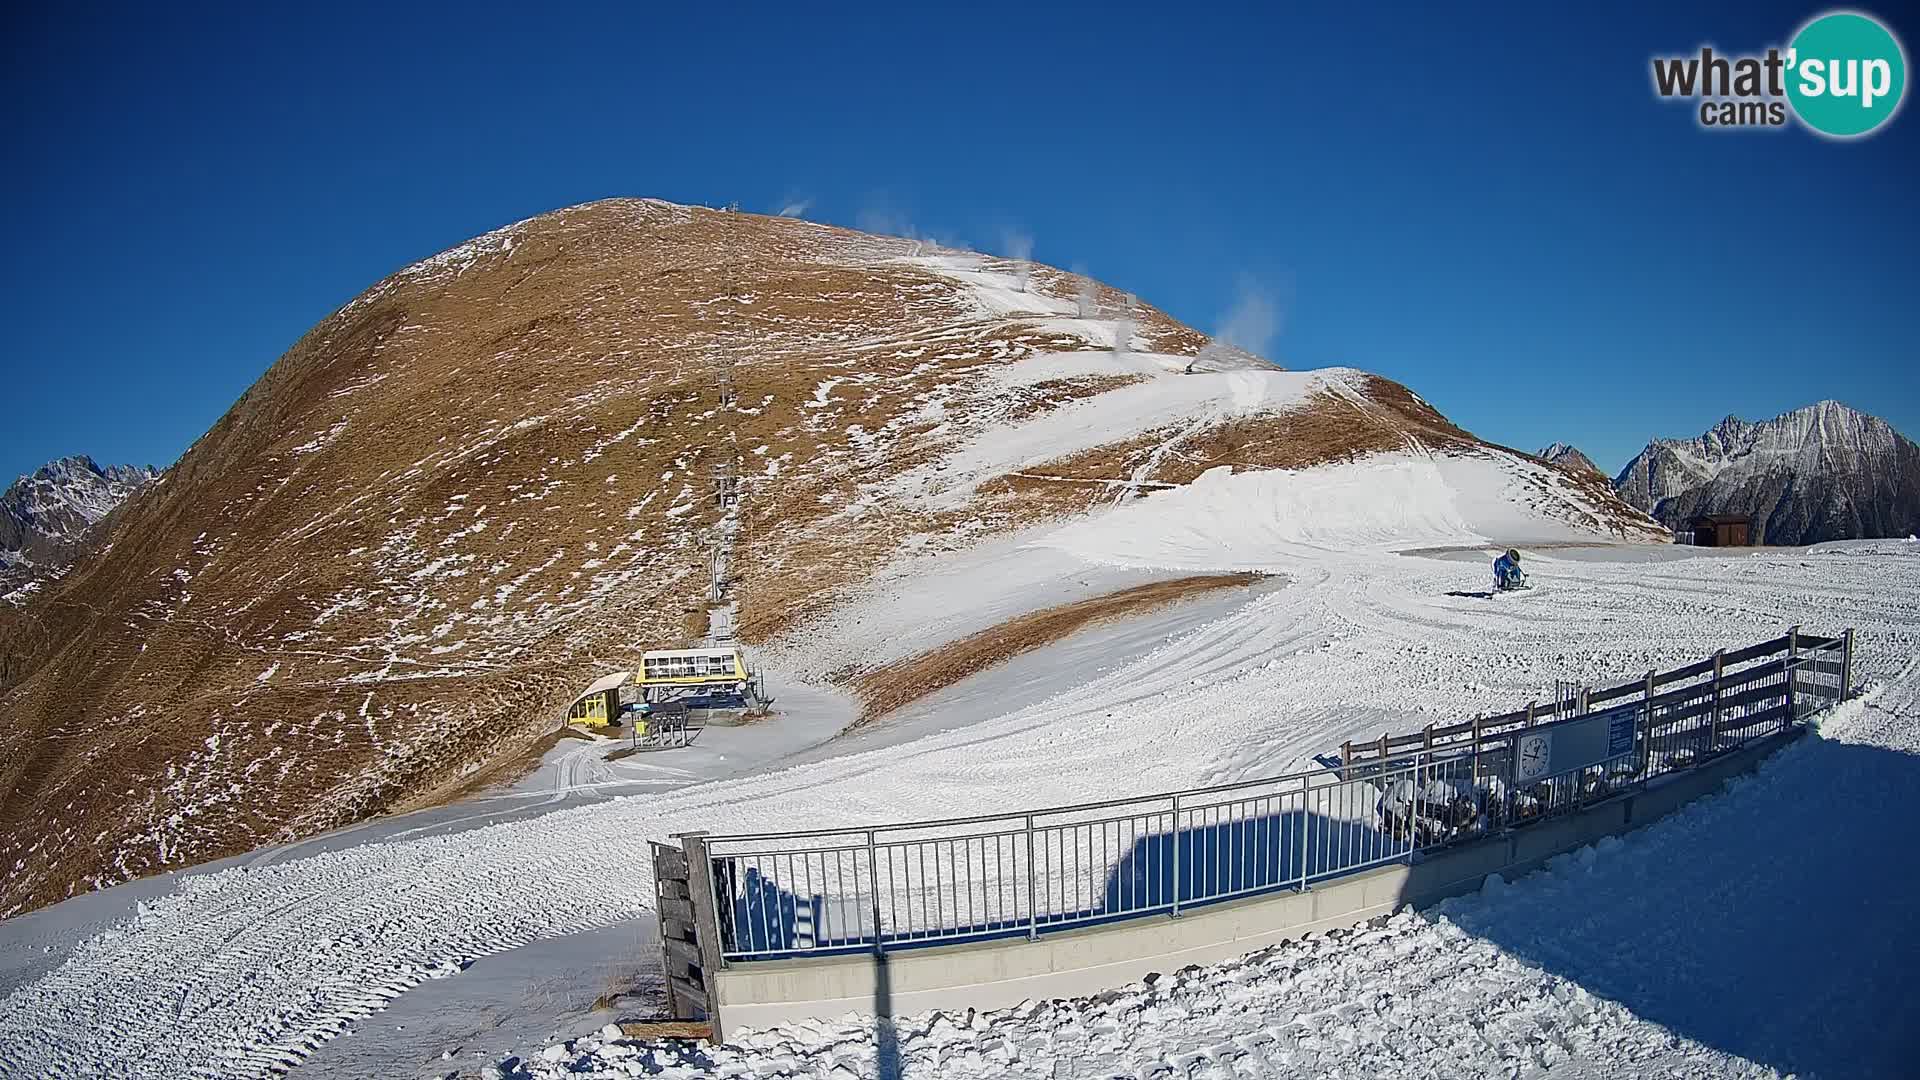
[714,726,1805,1038]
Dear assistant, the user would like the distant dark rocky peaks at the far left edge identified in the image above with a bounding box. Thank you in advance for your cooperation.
[0,454,159,592]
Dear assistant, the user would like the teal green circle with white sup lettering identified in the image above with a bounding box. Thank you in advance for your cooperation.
[1788,12,1907,138]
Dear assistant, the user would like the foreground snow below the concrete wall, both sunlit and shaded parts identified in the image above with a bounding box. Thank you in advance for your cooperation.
[501,669,1920,1080]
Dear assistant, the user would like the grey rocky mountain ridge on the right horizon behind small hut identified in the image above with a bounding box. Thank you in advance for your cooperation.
[1613,402,1920,544]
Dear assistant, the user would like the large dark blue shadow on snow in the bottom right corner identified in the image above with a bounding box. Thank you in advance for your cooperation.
[1409,736,1920,1076]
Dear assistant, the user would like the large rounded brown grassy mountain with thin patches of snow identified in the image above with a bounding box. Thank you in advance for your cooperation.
[0,200,1644,915]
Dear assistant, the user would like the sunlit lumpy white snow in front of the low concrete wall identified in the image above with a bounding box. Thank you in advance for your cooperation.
[499,913,1772,1080]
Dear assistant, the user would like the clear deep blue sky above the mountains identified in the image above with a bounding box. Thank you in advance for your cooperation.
[0,4,1920,477]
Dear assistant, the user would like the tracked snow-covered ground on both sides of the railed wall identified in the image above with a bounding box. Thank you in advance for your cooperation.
[0,499,1920,1076]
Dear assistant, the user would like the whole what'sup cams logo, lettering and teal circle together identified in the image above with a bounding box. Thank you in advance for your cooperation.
[1653,12,1907,138]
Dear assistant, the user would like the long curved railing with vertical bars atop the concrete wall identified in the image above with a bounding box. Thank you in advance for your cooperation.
[701,630,1853,961]
